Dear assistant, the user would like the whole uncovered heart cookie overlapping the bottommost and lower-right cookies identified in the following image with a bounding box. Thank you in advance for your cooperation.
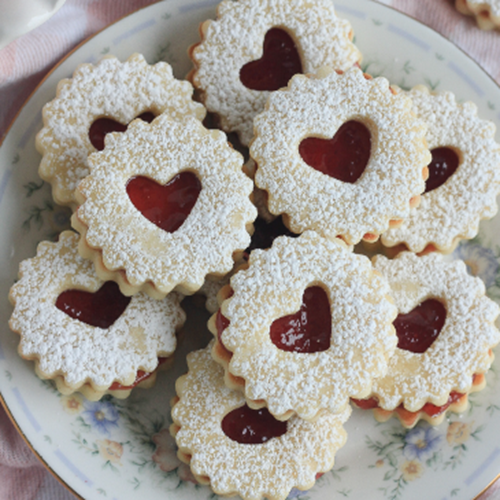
[209,231,396,420]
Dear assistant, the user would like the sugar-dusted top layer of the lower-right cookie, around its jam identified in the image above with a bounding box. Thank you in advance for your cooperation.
[372,252,500,412]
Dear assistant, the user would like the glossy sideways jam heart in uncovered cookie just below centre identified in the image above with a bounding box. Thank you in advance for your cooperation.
[270,286,332,353]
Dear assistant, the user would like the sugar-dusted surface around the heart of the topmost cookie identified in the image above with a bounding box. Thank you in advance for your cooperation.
[192,0,361,145]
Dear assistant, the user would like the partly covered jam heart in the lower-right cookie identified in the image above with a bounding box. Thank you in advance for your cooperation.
[394,299,446,354]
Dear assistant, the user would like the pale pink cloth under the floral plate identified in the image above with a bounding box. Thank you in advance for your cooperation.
[0,0,500,500]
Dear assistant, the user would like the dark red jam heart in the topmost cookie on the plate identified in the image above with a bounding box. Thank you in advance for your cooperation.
[240,28,302,91]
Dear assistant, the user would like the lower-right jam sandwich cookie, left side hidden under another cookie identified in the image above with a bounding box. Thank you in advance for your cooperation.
[354,252,500,427]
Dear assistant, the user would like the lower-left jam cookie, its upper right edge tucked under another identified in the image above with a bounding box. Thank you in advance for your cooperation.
[9,231,185,400]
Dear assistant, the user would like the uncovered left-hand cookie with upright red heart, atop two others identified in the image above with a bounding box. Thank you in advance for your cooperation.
[72,113,257,298]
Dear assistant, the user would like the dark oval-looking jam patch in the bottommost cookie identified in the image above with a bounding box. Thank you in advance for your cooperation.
[221,405,287,444]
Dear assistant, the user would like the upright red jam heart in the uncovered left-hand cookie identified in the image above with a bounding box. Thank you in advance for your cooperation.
[127,172,201,233]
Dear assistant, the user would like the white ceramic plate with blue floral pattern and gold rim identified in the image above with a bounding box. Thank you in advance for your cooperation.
[0,0,500,500]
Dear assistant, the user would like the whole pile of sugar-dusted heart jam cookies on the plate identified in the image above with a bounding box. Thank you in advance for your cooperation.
[6,0,500,500]
